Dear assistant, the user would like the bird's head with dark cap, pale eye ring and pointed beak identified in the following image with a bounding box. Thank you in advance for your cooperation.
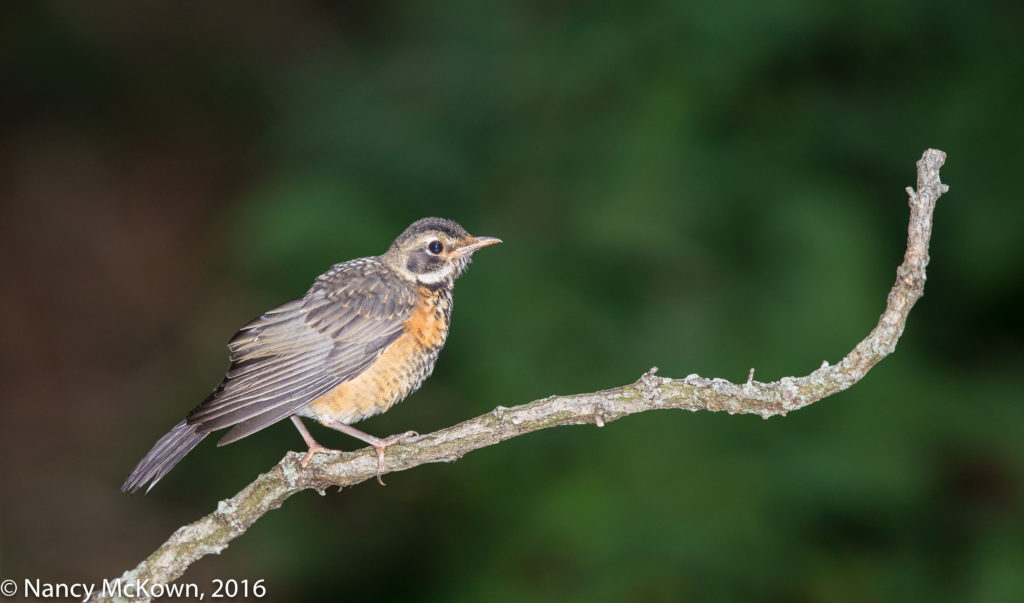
[382,218,502,287]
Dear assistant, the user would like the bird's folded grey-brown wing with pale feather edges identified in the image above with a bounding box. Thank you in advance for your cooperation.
[185,260,417,444]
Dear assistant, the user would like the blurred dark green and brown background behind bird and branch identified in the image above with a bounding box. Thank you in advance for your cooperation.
[0,0,1024,603]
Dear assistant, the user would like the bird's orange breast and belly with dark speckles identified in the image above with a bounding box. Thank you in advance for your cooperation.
[300,287,452,424]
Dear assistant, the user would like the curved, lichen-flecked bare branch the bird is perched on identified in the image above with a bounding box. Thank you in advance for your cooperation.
[93,149,948,601]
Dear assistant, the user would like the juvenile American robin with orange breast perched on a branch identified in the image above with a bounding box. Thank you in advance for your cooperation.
[121,218,501,492]
